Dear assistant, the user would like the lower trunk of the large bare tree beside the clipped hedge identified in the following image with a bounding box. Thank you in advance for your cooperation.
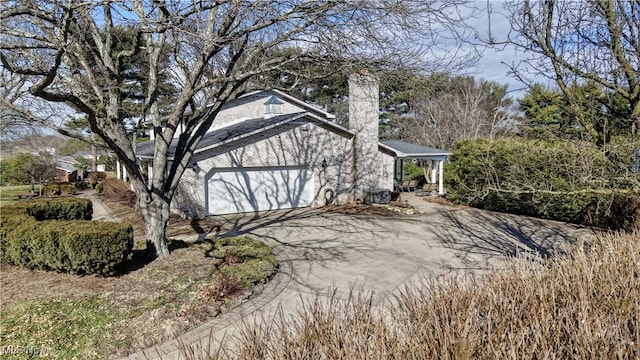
[139,195,169,259]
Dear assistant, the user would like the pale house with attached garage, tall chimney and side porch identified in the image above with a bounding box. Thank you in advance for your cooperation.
[135,74,449,217]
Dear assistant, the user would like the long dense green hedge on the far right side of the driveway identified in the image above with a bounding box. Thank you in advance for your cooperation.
[445,139,640,230]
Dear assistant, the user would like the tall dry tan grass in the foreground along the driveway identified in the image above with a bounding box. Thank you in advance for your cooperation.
[195,232,640,359]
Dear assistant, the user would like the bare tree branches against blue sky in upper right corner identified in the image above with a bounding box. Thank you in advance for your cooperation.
[497,0,640,139]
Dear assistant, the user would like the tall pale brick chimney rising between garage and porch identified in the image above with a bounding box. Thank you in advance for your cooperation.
[349,70,380,199]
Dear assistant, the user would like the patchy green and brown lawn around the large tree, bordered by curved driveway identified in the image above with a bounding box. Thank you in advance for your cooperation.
[0,195,277,359]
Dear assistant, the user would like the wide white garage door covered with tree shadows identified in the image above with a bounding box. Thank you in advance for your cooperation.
[206,168,313,215]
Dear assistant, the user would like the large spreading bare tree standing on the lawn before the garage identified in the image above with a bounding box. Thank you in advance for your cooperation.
[0,0,480,257]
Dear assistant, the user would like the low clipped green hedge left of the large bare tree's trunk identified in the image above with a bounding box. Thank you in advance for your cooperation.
[0,199,133,276]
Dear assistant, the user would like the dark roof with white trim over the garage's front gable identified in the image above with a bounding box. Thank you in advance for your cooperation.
[136,112,353,159]
